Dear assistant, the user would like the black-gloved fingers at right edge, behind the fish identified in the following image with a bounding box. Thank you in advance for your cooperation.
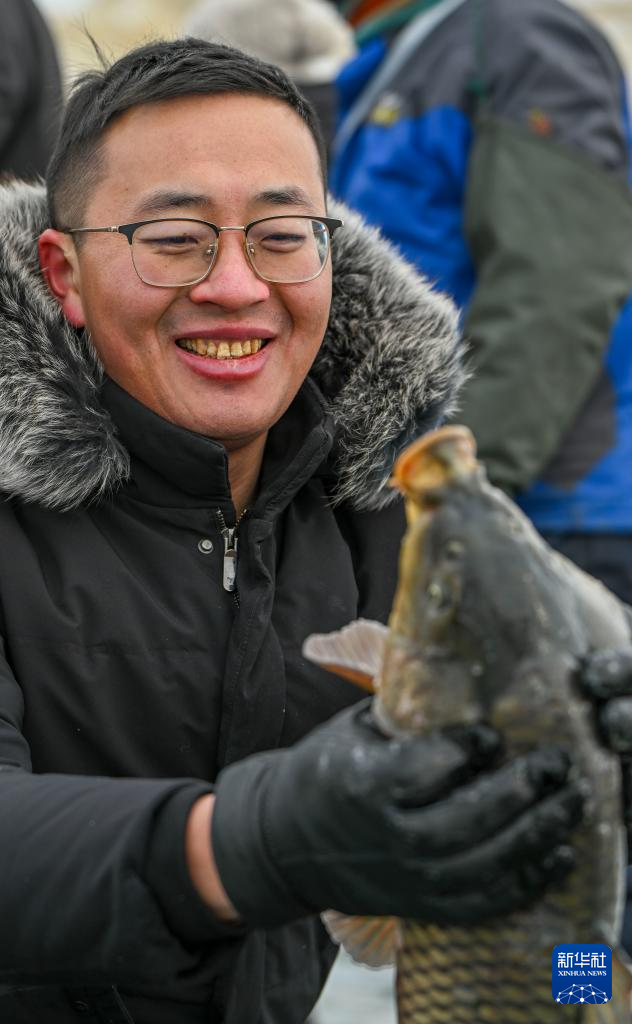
[577,646,632,857]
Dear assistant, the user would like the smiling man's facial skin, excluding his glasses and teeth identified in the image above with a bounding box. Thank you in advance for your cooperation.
[56,95,331,449]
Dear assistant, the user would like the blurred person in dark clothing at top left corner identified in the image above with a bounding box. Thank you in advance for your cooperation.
[0,0,62,178]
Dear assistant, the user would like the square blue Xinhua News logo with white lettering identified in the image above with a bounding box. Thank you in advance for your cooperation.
[551,942,613,1005]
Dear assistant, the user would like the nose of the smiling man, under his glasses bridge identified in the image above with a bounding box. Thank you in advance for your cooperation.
[184,230,270,309]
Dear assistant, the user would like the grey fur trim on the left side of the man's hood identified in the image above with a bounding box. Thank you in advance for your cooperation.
[0,181,129,511]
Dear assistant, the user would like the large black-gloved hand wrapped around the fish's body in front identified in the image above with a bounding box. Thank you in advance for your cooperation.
[212,702,583,927]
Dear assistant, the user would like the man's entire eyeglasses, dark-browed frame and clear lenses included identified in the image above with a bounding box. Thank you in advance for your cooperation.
[66,214,342,288]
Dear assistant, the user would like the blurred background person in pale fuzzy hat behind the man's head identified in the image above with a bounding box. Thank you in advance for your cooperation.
[183,0,355,146]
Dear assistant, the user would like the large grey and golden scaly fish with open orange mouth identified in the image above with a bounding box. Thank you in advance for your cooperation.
[303,425,632,1024]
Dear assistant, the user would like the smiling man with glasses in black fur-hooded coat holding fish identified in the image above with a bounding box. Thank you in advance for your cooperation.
[0,40,598,1024]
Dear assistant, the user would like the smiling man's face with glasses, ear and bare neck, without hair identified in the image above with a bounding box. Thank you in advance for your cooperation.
[40,93,335,511]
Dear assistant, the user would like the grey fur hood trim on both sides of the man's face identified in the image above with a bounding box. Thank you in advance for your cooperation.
[0,182,463,511]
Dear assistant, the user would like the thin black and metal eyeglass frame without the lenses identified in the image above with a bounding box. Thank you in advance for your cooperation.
[62,213,344,288]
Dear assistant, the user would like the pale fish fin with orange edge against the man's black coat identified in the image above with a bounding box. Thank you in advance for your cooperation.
[303,618,388,692]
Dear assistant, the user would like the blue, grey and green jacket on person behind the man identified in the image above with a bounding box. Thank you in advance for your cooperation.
[331,0,632,532]
